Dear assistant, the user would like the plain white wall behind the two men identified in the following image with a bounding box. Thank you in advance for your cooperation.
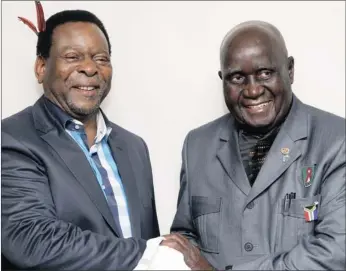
[2,1,345,233]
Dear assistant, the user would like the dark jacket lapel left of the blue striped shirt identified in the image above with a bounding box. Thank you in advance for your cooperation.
[34,98,120,236]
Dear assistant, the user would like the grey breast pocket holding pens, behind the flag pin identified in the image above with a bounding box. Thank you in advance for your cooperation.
[275,194,321,251]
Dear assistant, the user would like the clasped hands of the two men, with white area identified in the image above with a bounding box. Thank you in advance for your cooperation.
[135,233,214,270]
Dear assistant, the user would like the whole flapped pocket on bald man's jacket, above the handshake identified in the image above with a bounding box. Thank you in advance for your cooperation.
[191,196,222,253]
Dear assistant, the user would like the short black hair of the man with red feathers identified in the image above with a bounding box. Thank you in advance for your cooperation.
[36,10,111,59]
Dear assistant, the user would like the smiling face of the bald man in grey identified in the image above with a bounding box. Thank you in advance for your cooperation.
[219,28,294,129]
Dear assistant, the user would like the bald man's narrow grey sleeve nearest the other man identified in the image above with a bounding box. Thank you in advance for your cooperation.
[171,135,198,245]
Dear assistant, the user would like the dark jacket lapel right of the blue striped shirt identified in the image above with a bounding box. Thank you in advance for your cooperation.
[108,133,141,238]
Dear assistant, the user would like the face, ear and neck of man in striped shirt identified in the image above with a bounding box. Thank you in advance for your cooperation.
[35,22,112,147]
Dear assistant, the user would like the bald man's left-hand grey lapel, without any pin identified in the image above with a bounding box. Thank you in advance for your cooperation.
[216,117,251,195]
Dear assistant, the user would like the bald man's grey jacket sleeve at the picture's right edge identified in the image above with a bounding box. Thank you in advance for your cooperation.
[232,141,346,270]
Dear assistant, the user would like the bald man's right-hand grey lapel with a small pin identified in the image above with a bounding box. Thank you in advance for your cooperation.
[246,97,308,204]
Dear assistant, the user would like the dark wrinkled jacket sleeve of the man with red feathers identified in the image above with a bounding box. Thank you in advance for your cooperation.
[1,132,146,270]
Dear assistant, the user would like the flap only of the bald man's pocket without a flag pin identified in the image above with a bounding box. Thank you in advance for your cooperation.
[191,196,221,219]
